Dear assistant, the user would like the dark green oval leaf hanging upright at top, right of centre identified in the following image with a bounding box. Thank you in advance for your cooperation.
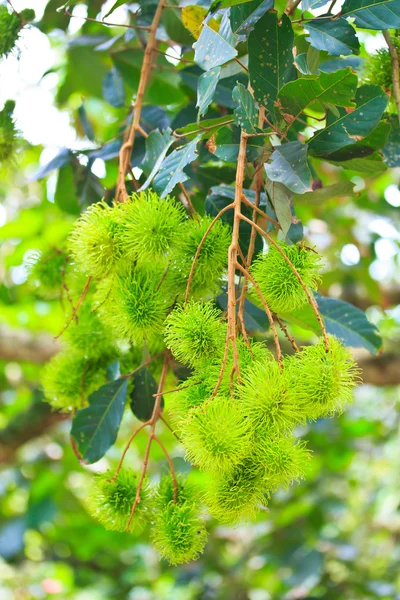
[248,12,296,112]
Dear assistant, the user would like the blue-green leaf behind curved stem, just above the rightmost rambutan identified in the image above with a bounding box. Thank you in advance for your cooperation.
[285,296,382,354]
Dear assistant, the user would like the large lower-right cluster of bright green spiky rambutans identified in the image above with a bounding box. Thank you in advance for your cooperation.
[165,300,357,524]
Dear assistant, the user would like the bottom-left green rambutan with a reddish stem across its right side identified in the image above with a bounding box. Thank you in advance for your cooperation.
[87,468,150,533]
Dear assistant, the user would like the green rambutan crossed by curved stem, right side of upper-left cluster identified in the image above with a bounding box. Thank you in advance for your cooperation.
[170,216,231,298]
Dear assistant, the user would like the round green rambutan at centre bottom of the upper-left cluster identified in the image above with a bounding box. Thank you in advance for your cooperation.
[95,265,174,343]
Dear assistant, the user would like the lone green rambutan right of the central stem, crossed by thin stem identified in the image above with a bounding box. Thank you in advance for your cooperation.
[251,242,322,314]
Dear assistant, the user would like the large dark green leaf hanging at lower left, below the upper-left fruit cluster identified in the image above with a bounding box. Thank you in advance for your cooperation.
[71,379,128,464]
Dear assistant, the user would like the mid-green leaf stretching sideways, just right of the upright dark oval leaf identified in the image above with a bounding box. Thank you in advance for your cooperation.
[278,67,357,122]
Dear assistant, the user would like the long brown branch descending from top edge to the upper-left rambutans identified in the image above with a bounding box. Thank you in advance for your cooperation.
[115,0,165,202]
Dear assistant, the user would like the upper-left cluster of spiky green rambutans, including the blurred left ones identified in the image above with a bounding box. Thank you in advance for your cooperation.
[37,192,230,410]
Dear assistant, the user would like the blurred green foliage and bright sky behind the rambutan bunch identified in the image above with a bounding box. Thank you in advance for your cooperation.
[0,0,400,600]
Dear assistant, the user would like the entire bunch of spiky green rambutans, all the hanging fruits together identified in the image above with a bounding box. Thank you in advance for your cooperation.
[30,192,357,564]
